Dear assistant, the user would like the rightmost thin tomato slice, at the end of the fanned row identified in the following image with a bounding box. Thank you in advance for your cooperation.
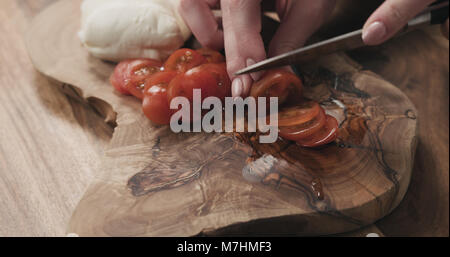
[297,115,339,148]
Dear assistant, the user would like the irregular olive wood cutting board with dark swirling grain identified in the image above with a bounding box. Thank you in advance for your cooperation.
[27,0,418,236]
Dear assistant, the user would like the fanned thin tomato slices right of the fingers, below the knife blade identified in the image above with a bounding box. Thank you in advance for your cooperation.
[251,69,338,147]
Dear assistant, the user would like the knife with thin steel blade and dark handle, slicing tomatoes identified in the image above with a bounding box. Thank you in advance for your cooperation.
[235,0,449,75]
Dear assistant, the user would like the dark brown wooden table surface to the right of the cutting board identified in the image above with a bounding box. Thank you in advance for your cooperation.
[351,27,449,236]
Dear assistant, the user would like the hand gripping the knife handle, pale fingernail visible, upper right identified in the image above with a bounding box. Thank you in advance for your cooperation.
[363,0,449,45]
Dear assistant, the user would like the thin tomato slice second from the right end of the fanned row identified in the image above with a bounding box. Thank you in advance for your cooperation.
[279,109,327,141]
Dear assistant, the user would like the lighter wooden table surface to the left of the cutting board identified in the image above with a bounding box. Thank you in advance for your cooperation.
[0,0,112,236]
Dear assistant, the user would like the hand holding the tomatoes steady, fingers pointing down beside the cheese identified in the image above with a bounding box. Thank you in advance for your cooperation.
[180,0,335,97]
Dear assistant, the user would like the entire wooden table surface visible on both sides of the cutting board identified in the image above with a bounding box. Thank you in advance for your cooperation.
[0,0,449,236]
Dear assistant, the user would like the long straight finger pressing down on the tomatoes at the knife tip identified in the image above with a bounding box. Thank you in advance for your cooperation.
[221,0,266,97]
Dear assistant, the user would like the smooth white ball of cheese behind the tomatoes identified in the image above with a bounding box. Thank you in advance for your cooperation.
[79,0,191,61]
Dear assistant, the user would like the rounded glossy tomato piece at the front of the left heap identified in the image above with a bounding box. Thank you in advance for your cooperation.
[142,71,177,125]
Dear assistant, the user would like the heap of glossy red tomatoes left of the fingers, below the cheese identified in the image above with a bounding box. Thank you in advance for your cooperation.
[110,49,231,125]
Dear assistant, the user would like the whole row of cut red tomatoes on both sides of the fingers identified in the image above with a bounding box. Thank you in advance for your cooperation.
[110,49,338,147]
